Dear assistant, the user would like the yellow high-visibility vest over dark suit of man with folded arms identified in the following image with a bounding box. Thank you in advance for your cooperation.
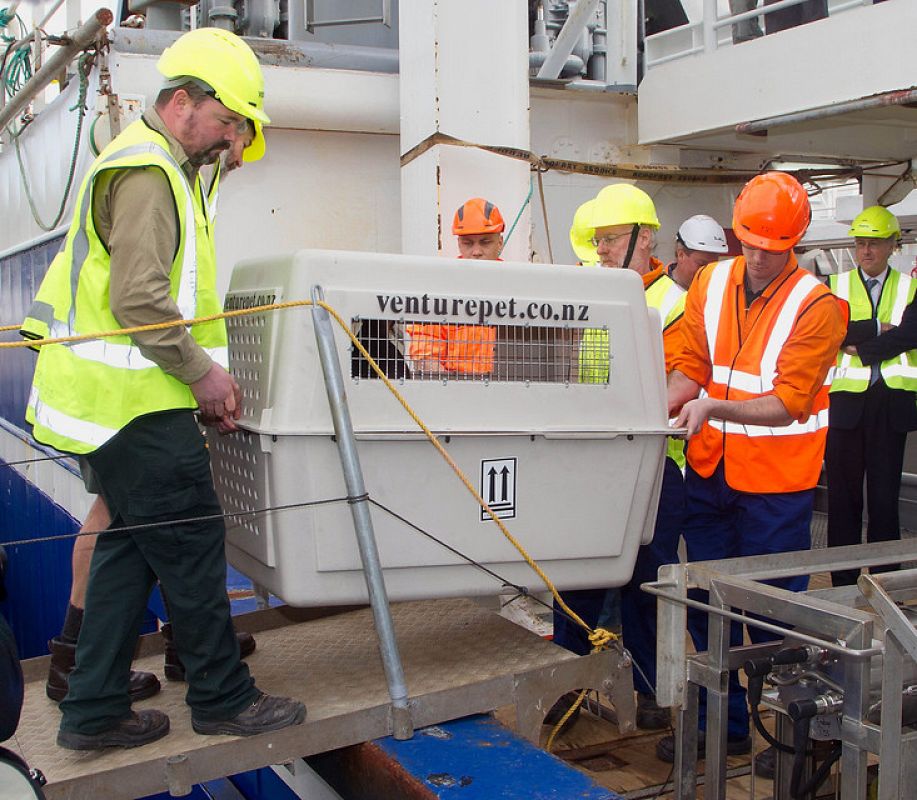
[828,269,917,392]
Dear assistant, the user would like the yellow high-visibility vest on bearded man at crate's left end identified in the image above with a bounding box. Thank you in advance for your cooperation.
[22,120,228,454]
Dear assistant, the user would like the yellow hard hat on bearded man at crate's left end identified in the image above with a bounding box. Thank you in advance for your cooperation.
[156,28,271,161]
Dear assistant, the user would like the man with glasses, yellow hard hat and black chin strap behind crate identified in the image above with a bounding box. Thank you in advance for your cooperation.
[554,183,685,730]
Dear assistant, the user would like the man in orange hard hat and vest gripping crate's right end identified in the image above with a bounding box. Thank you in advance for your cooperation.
[656,172,847,761]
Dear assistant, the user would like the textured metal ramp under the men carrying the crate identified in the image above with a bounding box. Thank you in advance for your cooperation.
[6,599,634,800]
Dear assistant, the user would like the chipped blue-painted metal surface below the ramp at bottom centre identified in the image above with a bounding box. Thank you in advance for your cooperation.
[375,715,620,800]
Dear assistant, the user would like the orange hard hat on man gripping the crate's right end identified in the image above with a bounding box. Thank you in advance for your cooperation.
[732,172,812,253]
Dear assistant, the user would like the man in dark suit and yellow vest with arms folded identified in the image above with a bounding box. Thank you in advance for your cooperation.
[825,206,917,586]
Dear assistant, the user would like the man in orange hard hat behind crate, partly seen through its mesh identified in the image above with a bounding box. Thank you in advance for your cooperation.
[405,197,506,379]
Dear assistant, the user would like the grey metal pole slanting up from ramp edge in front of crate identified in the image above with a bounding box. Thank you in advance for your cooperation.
[312,286,414,739]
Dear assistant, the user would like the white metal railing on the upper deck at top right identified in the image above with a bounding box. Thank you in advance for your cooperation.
[645,0,873,71]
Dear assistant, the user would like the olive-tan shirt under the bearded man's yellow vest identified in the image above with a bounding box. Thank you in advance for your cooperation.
[92,108,213,384]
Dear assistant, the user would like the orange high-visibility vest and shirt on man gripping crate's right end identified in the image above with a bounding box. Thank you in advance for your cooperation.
[674,256,846,494]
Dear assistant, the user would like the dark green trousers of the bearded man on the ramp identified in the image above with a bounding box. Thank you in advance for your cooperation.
[61,411,257,734]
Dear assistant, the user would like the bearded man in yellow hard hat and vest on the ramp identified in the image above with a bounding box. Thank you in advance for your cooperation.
[23,28,305,750]
